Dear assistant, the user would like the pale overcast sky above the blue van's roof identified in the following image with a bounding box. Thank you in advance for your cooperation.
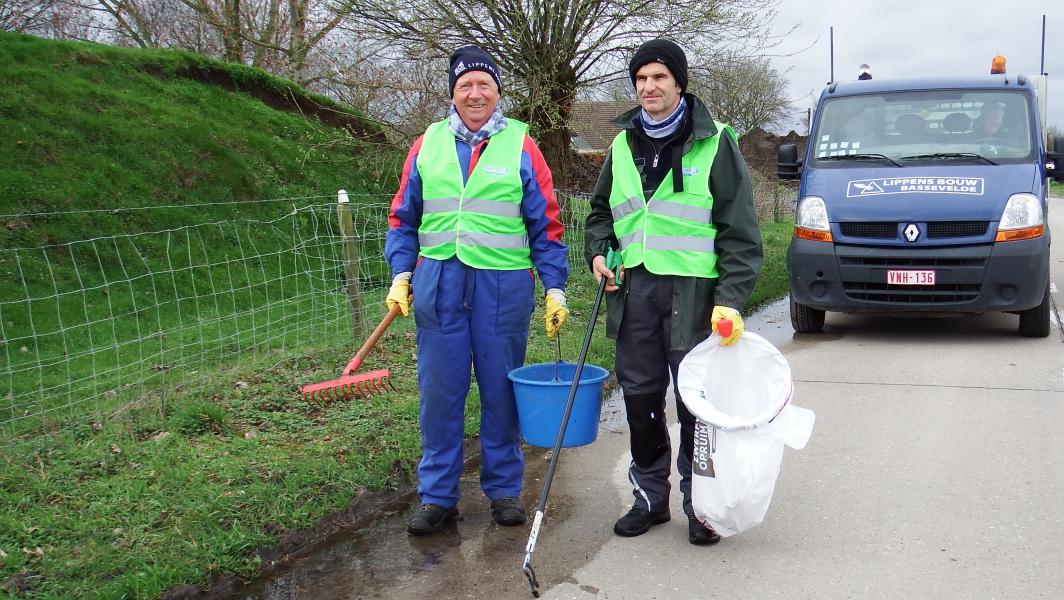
[769,0,1064,133]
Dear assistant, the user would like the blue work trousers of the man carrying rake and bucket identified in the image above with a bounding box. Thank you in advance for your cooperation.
[412,257,535,506]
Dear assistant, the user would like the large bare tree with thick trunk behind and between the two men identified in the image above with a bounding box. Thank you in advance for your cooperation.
[356,0,778,182]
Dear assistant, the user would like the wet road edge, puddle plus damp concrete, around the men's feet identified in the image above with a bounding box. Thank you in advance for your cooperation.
[234,387,628,600]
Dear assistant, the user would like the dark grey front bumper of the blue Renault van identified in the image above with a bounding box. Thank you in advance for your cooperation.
[787,234,1049,313]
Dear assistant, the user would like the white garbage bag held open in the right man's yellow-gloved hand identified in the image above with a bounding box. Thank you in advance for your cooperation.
[677,332,815,537]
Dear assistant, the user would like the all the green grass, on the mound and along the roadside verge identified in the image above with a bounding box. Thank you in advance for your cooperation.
[0,29,791,598]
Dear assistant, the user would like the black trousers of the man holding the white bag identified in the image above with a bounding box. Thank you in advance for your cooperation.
[616,267,695,515]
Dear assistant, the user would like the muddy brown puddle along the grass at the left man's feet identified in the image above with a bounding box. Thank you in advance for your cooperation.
[233,448,582,600]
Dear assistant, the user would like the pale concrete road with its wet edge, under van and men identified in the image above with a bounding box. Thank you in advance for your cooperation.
[240,199,1064,600]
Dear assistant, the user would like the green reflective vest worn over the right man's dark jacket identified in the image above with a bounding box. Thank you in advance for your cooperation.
[610,121,731,278]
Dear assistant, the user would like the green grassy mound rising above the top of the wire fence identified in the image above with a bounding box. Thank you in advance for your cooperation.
[0,34,391,223]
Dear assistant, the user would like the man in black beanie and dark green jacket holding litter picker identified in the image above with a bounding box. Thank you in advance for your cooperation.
[584,39,762,546]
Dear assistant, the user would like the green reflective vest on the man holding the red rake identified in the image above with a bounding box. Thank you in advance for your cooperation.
[417,118,532,270]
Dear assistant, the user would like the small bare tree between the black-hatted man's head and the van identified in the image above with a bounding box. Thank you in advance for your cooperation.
[692,56,791,135]
